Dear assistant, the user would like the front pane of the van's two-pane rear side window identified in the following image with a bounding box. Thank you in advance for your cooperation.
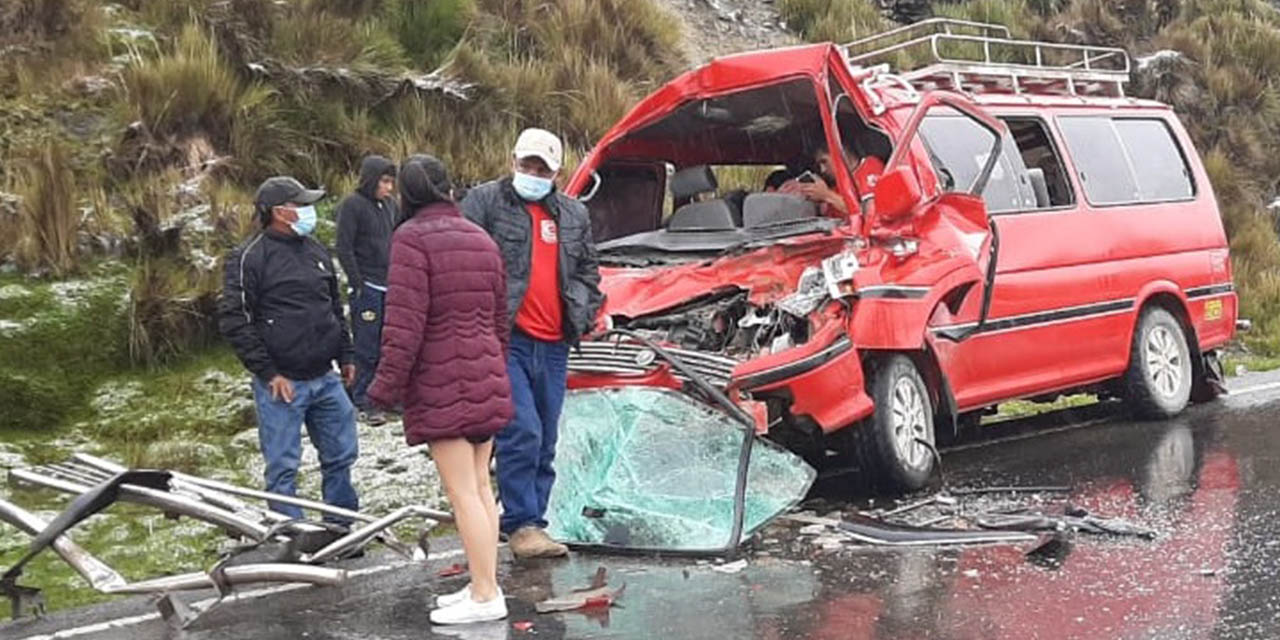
[1059,116,1142,205]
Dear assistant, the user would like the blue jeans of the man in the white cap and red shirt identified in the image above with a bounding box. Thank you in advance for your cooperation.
[494,332,568,534]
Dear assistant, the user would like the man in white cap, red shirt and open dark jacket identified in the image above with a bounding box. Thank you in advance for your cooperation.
[462,129,603,558]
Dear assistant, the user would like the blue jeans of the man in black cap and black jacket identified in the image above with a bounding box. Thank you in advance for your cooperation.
[253,372,360,525]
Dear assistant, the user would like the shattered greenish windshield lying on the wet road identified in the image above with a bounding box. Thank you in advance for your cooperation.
[547,387,817,552]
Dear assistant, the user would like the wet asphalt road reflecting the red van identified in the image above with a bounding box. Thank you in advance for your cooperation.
[0,378,1280,640]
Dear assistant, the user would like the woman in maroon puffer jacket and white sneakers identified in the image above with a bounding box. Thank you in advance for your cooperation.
[369,156,512,625]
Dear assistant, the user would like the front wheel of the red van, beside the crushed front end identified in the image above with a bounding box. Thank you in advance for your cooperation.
[854,355,937,492]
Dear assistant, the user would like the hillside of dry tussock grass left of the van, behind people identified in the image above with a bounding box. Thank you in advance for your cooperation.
[0,0,685,445]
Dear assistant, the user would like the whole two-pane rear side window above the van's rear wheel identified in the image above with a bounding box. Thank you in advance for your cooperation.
[1059,116,1196,205]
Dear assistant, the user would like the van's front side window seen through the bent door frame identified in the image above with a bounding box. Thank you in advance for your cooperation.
[920,109,1036,212]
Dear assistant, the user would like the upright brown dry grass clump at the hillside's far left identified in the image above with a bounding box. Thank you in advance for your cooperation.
[14,141,79,276]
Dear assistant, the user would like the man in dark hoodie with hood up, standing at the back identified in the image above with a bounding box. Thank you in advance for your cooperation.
[338,155,399,426]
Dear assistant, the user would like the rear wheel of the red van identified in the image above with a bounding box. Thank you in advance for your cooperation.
[1123,306,1194,420]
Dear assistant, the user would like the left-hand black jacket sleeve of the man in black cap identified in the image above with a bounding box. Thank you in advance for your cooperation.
[218,239,276,381]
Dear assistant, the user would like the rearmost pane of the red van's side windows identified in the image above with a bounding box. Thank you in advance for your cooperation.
[1115,118,1196,202]
